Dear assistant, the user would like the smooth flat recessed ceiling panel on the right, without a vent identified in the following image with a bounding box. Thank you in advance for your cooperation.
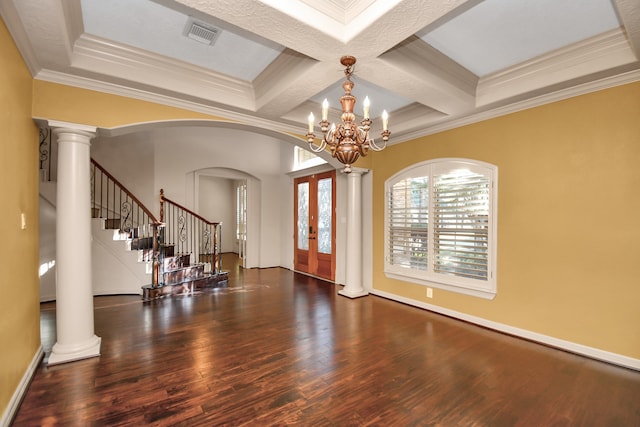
[419,0,620,77]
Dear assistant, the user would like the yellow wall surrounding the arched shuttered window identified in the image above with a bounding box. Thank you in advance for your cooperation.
[373,82,640,359]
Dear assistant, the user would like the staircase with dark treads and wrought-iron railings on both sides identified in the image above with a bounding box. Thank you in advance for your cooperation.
[91,159,228,301]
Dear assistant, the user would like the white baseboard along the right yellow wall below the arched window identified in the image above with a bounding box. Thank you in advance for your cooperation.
[370,289,640,371]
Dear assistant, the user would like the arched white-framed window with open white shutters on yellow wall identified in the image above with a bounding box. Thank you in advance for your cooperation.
[385,159,498,299]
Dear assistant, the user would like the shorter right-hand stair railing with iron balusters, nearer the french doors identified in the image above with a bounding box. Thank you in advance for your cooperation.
[160,189,222,274]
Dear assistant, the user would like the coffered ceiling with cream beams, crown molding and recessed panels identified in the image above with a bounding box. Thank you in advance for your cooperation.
[0,0,640,142]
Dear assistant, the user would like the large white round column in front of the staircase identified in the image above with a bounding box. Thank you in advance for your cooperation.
[48,121,101,365]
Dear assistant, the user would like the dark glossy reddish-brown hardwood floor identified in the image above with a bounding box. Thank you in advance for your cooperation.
[14,260,640,426]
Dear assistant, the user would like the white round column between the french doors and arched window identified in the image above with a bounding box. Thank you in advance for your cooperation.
[338,168,369,298]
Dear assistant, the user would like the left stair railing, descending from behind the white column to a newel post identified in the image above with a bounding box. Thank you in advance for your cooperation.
[91,159,162,287]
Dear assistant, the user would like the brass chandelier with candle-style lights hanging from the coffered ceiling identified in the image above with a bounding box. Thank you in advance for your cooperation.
[306,56,391,173]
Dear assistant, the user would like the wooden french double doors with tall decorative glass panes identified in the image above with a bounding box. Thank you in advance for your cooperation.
[293,170,336,281]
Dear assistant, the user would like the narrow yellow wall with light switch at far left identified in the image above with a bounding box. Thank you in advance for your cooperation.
[0,19,40,414]
